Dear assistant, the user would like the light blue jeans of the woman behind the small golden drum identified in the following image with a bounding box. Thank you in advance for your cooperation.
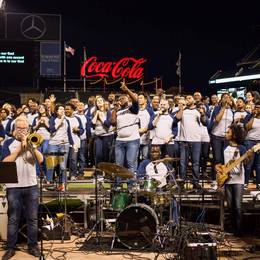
[46,144,69,182]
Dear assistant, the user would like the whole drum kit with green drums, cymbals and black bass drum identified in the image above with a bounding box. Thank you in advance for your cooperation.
[90,158,182,249]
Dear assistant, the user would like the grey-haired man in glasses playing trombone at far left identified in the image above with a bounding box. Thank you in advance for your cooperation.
[2,117,43,260]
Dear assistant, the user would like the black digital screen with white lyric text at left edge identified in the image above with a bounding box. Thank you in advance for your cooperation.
[0,41,37,80]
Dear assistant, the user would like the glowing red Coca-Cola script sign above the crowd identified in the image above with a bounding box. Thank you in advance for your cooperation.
[80,57,146,79]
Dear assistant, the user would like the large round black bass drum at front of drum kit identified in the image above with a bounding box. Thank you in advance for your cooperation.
[116,204,159,249]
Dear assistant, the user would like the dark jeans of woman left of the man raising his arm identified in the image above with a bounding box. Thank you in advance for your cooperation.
[94,135,114,165]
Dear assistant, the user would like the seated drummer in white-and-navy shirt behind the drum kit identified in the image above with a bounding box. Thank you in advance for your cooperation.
[137,145,170,188]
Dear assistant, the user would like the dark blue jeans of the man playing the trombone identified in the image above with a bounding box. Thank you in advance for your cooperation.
[7,185,39,249]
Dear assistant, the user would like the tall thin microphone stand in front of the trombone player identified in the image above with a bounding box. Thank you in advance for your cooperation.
[28,142,45,260]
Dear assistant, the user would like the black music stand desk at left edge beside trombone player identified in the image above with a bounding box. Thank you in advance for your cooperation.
[0,162,18,183]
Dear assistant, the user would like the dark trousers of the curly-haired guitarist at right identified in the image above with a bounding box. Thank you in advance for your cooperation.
[225,184,244,233]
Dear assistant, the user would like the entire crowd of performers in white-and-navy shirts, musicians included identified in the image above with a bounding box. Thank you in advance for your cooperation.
[0,83,260,259]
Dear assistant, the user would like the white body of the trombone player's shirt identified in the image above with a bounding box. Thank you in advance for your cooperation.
[6,140,37,188]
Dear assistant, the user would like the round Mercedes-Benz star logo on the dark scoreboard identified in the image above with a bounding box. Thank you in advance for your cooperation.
[21,15,46,40]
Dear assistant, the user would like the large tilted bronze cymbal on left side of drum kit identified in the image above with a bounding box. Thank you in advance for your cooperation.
[98,162,134,179]
